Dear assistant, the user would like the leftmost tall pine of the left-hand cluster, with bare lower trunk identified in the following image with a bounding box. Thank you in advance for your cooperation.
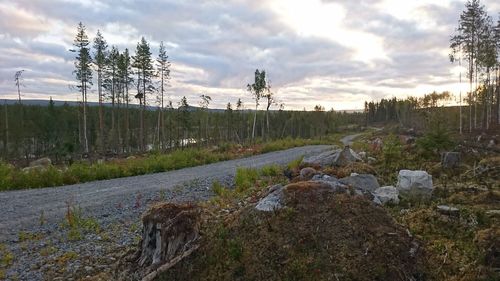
[72,22,92,154]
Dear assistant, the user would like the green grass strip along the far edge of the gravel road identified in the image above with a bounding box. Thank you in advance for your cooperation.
[0,134,352,191]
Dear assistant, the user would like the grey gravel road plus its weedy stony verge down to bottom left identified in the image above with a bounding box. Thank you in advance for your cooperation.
[0,145,329,281]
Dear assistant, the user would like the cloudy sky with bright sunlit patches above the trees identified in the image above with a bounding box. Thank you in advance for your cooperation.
[0,0,500,110]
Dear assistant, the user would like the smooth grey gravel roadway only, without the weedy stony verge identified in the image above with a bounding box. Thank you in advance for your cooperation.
[0,145,329,242]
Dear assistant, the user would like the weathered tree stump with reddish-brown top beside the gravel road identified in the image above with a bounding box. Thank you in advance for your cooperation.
[138,203,201,271]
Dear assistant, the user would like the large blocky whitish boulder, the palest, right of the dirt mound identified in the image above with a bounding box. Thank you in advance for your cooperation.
[396,170,434,196]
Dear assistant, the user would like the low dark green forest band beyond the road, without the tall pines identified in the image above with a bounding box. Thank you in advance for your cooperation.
[0,99,364,161]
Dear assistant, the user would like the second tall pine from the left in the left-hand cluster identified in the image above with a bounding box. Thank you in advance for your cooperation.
[93,30,108,152]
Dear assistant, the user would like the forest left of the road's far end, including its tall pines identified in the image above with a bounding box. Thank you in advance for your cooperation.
[0,23,363,161]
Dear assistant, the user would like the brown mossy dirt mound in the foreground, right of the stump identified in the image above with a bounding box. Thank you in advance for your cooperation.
[158,182,424,281]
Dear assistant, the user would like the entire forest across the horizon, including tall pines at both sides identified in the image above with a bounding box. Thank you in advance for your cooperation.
[0,0,500,161]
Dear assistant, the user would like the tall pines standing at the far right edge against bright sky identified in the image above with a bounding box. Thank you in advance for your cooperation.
[450,0,500,132]
